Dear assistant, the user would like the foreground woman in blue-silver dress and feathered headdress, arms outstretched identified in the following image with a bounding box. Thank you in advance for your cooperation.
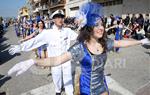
[8,3,150,95]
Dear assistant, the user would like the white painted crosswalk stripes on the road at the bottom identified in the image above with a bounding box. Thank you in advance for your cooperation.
[21,76,134,95]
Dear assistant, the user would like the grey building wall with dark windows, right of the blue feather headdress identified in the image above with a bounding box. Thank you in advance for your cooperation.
[92,0,150,16]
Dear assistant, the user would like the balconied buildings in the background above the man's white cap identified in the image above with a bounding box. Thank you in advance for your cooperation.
[29,0,66,16]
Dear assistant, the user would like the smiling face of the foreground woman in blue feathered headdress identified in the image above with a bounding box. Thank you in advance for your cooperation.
[93,21,105,39]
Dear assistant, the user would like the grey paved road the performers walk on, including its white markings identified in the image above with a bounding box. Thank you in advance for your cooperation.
[0,27,150,95]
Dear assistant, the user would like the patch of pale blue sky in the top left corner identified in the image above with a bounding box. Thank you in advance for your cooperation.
[0,0,27,17]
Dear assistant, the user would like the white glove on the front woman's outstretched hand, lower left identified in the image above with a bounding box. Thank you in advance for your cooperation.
[8,59,34,76]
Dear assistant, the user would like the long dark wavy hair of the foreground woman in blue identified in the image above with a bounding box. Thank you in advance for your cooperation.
[77,26,107,52]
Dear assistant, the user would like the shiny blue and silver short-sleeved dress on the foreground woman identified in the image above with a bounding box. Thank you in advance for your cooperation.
[68,39,114,95]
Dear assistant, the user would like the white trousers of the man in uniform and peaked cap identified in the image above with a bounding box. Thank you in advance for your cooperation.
[51,61,73,95]
